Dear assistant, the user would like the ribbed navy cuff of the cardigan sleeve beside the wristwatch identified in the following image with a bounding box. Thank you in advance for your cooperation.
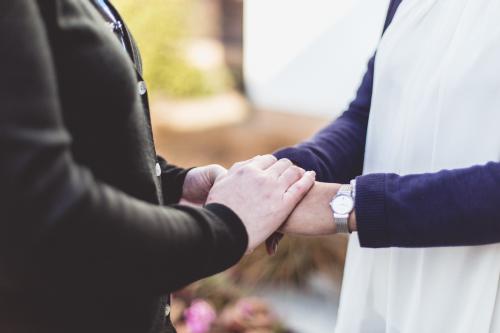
[356,174,391,248]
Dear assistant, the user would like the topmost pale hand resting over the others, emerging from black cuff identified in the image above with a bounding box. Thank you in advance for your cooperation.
[207,155,315,252]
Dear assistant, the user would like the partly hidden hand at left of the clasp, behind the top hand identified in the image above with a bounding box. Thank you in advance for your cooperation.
[182,164,227,205]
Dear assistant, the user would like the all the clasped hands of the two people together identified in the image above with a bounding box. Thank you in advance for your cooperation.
[182,155,350,254]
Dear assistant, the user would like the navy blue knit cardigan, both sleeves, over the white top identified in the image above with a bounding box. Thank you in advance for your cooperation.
[275,0,500,248]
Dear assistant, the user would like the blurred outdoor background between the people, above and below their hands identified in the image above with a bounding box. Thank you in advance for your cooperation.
[113,0,389,333]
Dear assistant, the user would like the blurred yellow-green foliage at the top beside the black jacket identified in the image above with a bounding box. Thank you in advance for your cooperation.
[113,0,230,97]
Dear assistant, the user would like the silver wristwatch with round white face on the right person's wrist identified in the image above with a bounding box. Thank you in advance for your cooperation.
[330,181,356,234]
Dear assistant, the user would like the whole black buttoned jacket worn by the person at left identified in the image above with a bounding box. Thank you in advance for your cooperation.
[0,0,247,333]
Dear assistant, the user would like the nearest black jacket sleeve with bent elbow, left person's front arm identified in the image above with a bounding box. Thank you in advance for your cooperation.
[0,0,247,293]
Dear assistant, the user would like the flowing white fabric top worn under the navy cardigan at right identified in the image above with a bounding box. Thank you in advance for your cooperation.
[336,0,500,333]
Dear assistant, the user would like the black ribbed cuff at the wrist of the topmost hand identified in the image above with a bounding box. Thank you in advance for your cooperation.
[205,203,248,270]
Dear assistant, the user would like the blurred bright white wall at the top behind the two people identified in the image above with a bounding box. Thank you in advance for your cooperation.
[244,0,389,117]
